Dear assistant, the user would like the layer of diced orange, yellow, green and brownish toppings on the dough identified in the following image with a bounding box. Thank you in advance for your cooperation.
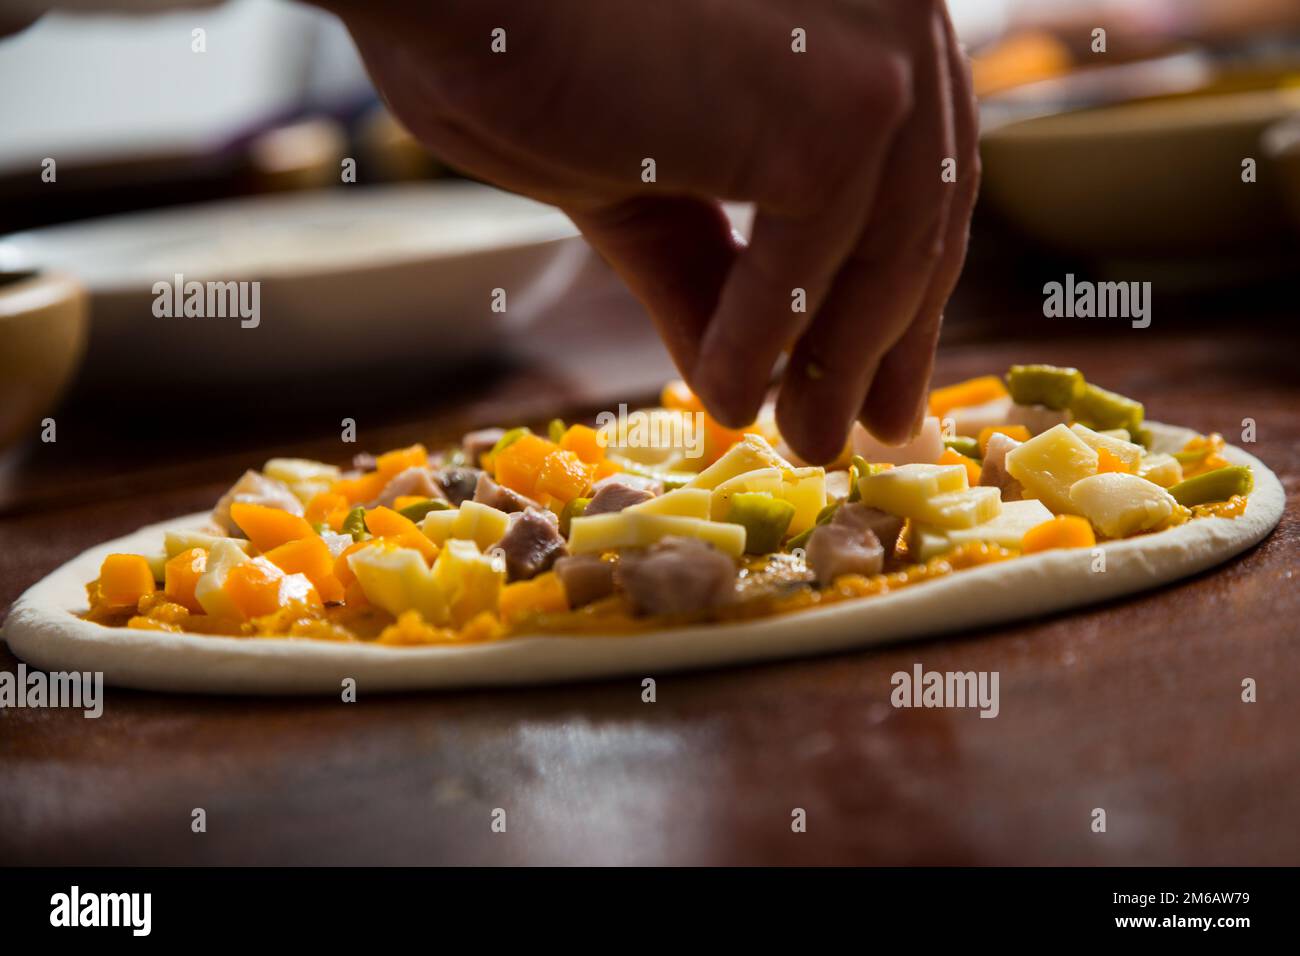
[87,365,1253,645]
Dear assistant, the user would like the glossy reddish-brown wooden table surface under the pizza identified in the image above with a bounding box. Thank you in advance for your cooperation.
[0,260,1300,864]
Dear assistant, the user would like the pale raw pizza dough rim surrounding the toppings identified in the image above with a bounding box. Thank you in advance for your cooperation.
[4,423,1284,695]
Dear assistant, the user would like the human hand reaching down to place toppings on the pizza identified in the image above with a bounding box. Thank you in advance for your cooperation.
[324,0,979,462]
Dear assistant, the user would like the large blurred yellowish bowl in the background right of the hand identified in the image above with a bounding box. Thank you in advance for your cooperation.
[982,86,1300,256]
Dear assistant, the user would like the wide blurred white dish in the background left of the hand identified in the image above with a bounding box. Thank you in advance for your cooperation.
[0,182,589,384]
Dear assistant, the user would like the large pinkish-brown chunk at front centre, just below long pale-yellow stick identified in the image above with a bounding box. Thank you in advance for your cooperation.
[614,537,736,614]
